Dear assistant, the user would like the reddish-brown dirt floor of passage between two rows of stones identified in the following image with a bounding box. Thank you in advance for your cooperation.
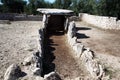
[45,33,84,80]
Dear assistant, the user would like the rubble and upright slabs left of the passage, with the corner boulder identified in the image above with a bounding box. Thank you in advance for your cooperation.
[4,26,44,80]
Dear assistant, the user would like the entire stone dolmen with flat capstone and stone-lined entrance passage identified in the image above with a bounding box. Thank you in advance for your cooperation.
[4,8,107,80]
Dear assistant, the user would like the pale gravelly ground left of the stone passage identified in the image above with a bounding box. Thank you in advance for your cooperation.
[0,21,41,80]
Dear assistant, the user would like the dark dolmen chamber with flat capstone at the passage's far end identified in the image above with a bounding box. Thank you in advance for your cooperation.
[37,8,73,32]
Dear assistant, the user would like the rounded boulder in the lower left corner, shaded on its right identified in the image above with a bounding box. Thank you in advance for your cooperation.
[4,64,22,80]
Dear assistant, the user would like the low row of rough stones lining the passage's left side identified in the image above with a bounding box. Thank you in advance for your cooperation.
[4,27,44,80]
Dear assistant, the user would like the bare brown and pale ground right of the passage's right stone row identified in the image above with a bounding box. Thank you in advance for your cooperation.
[76,22,120,80]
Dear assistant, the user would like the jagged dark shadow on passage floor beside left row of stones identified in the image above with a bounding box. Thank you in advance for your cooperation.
[43,32,64,75]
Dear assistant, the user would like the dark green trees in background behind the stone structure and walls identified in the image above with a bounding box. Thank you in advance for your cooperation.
[0,0,120,19]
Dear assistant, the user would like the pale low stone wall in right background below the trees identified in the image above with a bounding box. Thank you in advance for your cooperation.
[79,13,120,29]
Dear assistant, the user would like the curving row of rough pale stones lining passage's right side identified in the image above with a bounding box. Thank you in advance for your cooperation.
[67,21,105,80]
